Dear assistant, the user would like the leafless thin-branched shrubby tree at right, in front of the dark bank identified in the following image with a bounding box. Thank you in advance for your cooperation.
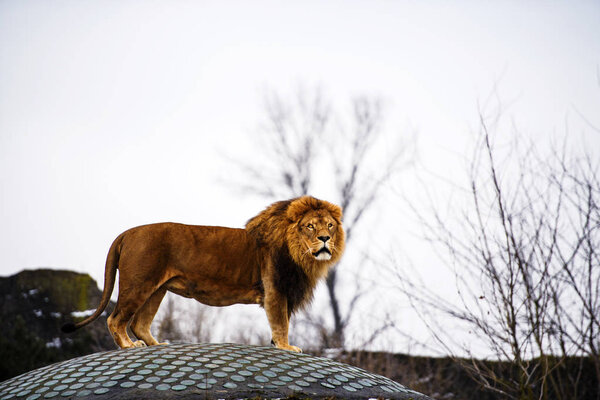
[399,111,600,399]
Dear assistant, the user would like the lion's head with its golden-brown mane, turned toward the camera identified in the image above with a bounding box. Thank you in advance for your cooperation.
[246,196,345,275]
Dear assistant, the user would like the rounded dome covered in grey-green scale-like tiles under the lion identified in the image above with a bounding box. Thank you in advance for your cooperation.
[0,344,429,400]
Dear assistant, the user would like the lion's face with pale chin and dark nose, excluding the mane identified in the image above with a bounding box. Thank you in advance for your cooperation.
[298,210,338,261]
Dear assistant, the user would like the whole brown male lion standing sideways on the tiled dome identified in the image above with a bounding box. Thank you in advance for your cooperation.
[62,196,345,352]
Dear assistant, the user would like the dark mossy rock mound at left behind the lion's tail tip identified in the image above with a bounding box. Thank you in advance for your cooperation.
[0,269,115,380]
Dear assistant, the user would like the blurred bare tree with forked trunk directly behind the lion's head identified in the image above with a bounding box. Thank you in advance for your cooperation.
[232,85,406,347]
